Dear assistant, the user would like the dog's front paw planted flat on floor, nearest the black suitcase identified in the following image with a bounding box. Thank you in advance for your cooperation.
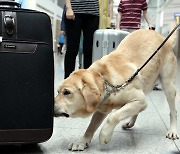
[68,137,90,151]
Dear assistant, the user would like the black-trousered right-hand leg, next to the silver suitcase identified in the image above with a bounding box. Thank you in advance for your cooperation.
[83,14,99,69]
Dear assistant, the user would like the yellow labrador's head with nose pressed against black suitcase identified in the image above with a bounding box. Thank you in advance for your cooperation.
[54,69,102,117]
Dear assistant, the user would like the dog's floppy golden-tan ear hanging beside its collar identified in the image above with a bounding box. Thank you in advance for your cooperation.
[82,84,100,112]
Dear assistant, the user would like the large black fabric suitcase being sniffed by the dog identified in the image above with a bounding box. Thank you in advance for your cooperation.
[0,1,54,144]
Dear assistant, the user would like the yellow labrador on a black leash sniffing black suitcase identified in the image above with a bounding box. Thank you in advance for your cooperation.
[55,29,179,151]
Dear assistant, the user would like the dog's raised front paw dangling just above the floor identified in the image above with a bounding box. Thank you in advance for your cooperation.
[99,125,113,145]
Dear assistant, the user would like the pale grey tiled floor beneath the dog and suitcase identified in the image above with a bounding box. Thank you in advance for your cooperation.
[0,54,180,154]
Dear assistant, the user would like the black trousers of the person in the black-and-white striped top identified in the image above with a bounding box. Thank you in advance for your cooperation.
[64,14,99,78]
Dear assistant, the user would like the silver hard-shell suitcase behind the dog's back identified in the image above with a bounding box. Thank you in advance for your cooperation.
[92,29,129,62]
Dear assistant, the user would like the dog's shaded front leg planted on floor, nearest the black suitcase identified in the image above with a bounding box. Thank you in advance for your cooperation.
[68,112,106,151]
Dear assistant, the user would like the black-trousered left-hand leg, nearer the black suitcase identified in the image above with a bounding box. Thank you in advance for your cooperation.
[64,14,82,78]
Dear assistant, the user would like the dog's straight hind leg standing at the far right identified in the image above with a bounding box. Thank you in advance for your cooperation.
[161,55,179,140]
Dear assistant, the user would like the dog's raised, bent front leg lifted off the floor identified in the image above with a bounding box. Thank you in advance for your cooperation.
[99,97,147,145]
